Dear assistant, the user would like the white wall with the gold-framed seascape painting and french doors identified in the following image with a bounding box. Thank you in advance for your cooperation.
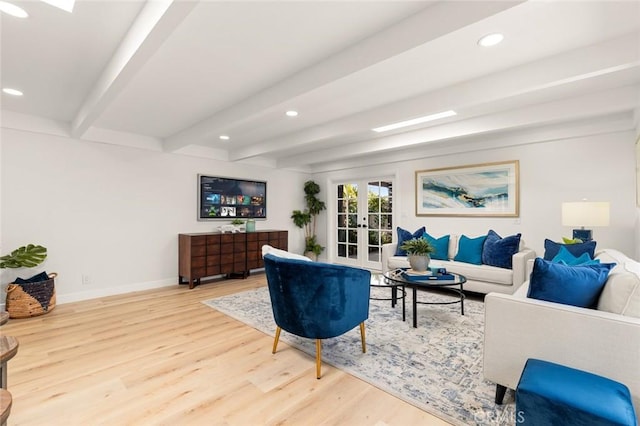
[314,131,637,257]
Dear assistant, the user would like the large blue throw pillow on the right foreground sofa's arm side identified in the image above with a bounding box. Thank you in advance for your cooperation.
[527,257,616,308]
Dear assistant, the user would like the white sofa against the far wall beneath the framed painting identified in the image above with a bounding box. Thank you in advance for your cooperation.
[382,234,536,294]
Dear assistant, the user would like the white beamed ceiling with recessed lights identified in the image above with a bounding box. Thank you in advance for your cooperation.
[0,0,640,172]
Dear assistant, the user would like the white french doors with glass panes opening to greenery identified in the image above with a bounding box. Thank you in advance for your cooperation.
[335,179,393,269]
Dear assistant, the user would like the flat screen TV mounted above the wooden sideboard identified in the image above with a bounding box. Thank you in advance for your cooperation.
[198,175,267,220]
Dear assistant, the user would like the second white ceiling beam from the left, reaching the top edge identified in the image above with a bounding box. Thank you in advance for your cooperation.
[165,0,523,151]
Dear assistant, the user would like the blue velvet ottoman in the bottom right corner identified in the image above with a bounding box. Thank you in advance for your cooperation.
[516,359,638,426]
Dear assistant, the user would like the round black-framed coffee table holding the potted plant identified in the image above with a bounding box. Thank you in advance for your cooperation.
[383,269,467,328]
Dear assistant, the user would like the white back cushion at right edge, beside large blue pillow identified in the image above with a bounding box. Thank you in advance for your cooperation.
[596,249,640,318]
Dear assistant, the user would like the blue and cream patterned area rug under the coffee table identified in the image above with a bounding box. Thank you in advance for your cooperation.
[202,287,515,425]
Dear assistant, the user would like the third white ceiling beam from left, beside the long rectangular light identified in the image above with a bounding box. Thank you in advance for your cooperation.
[229,34,640,161]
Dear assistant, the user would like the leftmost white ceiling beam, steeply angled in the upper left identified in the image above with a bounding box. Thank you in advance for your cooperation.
[71,0,197,138]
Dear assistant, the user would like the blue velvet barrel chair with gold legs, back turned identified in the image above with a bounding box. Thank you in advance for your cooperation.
[264,254,371,379]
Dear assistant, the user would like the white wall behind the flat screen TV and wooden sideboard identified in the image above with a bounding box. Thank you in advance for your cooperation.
[0,129,308,303]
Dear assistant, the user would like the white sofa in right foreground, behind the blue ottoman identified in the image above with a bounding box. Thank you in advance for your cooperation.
[484,249,640,415]
